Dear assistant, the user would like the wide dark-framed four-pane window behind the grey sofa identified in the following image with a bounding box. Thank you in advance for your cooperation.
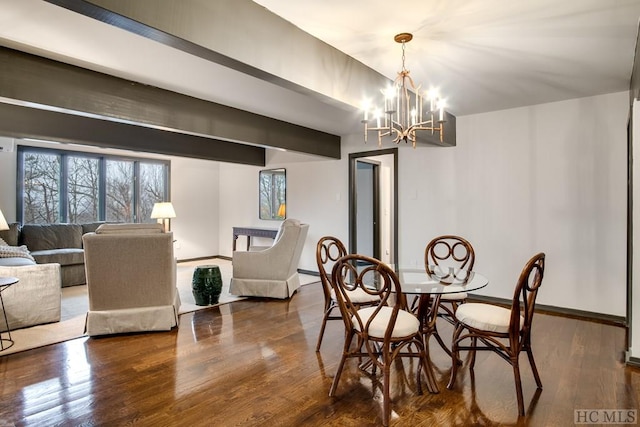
[17,146,170,224]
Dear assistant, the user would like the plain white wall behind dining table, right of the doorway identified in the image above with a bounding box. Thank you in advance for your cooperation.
[398,92,628,316]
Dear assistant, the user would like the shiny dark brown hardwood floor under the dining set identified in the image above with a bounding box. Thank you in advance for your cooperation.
[0,284,640,427]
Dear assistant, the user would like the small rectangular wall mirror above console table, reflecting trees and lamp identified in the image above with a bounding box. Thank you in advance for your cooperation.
[258,169,287,220]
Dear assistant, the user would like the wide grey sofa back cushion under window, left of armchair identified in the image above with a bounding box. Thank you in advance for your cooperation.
[20,224,82,253]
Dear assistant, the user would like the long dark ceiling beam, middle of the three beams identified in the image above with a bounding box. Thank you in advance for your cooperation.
[0,47,340,159]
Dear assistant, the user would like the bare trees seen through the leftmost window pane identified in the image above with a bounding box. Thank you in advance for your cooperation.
[22,152,60,224]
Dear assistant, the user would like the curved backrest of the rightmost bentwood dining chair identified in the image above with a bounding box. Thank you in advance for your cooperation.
[509,253,545,342]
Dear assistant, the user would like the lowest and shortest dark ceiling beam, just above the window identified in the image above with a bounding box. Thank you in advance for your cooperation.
[0,103,265,166]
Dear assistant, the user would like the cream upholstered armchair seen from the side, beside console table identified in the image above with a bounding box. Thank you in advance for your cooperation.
[229,218,309,299]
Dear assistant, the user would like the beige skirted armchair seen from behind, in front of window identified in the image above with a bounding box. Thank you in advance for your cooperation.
[83,224,180,336]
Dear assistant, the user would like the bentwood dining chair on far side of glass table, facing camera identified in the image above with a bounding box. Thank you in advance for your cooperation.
[424,235,476,356]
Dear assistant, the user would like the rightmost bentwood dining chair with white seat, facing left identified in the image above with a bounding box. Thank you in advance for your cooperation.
[447,253,545,415]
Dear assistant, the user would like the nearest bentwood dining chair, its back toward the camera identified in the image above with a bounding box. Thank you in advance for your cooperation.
[329,254,428,426]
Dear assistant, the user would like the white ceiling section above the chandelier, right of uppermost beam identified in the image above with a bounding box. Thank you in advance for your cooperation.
[254,0,640,116]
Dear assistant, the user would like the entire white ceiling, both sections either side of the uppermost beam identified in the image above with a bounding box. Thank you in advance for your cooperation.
[0,0,640,134]
